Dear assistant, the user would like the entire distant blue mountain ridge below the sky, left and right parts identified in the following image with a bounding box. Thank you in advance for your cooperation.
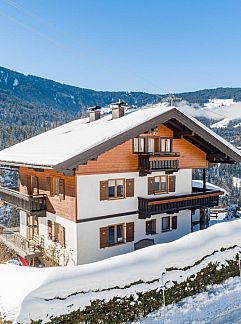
[0,66,241,115]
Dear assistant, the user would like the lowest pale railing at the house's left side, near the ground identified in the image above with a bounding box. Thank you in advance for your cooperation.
[0,225,42,257]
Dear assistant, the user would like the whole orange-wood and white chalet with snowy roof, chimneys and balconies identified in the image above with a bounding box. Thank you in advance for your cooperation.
[0,104,241,265]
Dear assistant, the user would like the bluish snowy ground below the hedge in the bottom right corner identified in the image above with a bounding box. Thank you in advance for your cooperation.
[138,277,241,324]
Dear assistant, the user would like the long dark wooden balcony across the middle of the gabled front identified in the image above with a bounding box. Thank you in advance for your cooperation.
[138,190,223,219]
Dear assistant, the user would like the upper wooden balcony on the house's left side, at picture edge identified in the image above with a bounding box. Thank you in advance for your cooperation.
[0,186,46,217]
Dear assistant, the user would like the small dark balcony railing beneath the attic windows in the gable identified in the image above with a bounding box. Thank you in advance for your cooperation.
[139,155,179,171]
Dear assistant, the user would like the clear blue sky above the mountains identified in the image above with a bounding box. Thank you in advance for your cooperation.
[0,0,241,93]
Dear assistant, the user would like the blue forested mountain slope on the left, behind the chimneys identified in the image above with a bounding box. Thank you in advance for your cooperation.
[0,67,162,114]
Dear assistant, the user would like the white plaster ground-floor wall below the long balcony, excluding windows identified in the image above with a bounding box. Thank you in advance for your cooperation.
[77,210,191,264]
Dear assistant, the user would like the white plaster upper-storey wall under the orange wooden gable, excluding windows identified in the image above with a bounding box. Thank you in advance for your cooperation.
[77,169,192,219]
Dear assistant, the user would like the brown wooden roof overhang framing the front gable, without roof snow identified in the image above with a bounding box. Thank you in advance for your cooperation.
[53,108,241,173]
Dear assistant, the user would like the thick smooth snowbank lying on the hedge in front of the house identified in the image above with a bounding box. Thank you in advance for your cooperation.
[0,220,241,323]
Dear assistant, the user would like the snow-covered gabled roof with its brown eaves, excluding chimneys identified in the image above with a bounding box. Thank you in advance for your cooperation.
[0,104,241,172]
